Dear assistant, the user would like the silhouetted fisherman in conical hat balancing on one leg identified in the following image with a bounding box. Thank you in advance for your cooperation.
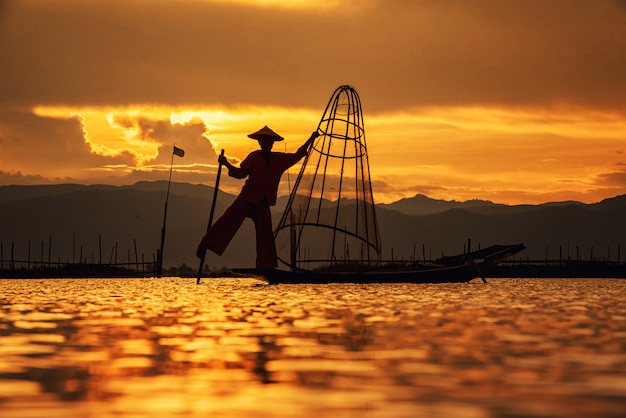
[196,125,319,269]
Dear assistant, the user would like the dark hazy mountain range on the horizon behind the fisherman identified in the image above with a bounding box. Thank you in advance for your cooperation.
[0,181,626,267]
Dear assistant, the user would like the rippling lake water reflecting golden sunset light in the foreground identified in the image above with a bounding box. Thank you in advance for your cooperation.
[0,278,626,418]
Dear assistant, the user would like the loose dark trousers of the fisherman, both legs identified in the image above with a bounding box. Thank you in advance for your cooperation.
[200,197,278,269]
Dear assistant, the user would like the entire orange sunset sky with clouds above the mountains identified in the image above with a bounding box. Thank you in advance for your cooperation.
[0,0,626,204]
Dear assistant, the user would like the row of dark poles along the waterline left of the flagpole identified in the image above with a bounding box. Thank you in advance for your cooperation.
[0,234,157,277]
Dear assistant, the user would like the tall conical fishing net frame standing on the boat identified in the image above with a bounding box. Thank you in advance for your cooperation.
[275,86,381,270]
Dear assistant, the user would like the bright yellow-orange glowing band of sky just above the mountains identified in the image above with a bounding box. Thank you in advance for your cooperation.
[23,105,626,203]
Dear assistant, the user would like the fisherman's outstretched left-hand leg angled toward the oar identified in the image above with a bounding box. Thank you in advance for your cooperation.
[196,198,253,257]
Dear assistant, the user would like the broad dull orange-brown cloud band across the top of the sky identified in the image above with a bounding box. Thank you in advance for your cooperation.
[0,0,626,111]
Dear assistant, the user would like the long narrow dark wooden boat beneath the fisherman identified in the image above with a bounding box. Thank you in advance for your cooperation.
[233,244,525,284]
